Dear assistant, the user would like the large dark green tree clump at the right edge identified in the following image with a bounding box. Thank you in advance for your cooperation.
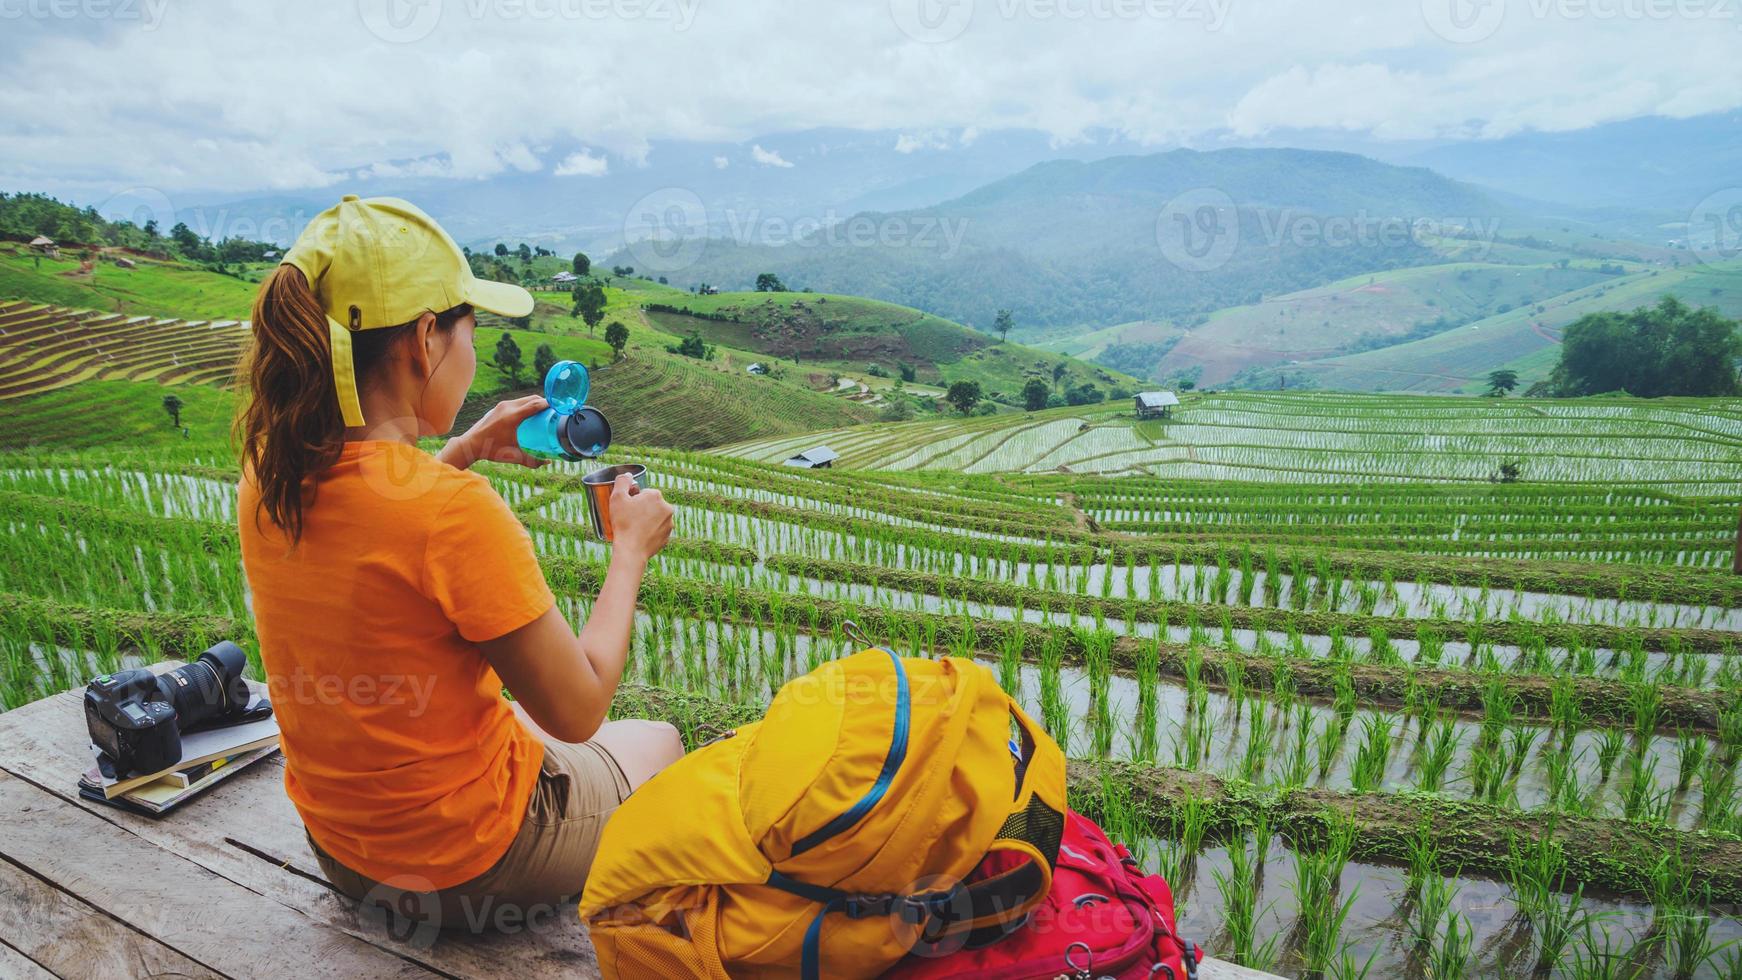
[1549,296,1742,399]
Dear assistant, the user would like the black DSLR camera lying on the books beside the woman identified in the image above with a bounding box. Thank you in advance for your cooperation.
[85,641,272,776]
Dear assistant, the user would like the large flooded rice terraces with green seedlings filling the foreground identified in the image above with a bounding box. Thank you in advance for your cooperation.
[10,397,1742,978]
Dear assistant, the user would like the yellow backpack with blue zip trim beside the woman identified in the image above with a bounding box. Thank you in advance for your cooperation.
[580,648,1066,980]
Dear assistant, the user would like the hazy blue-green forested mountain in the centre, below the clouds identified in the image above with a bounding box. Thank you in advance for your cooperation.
[627,150,1519,336]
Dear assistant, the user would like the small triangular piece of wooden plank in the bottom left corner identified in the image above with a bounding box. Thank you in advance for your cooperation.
[0,862,223,980]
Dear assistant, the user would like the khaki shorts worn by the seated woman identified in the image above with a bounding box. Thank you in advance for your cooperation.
[308,742,629,931]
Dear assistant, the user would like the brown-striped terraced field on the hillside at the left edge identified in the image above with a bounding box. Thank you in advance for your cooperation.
[0,301,247,399]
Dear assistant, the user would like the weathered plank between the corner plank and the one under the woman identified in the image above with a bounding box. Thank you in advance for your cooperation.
[0,775,430,980]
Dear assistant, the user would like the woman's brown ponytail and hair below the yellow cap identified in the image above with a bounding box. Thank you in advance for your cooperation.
[232,265,472,545]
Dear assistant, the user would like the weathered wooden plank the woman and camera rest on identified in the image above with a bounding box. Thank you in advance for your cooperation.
[0,691,599,980]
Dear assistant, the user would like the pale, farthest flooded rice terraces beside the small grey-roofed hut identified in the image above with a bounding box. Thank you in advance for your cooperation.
[723,393,1742,494]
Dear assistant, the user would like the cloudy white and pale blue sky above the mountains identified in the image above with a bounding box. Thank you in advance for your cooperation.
[0,0,1742,202]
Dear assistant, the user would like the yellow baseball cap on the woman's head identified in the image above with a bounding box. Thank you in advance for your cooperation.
[282,193,533,425]
